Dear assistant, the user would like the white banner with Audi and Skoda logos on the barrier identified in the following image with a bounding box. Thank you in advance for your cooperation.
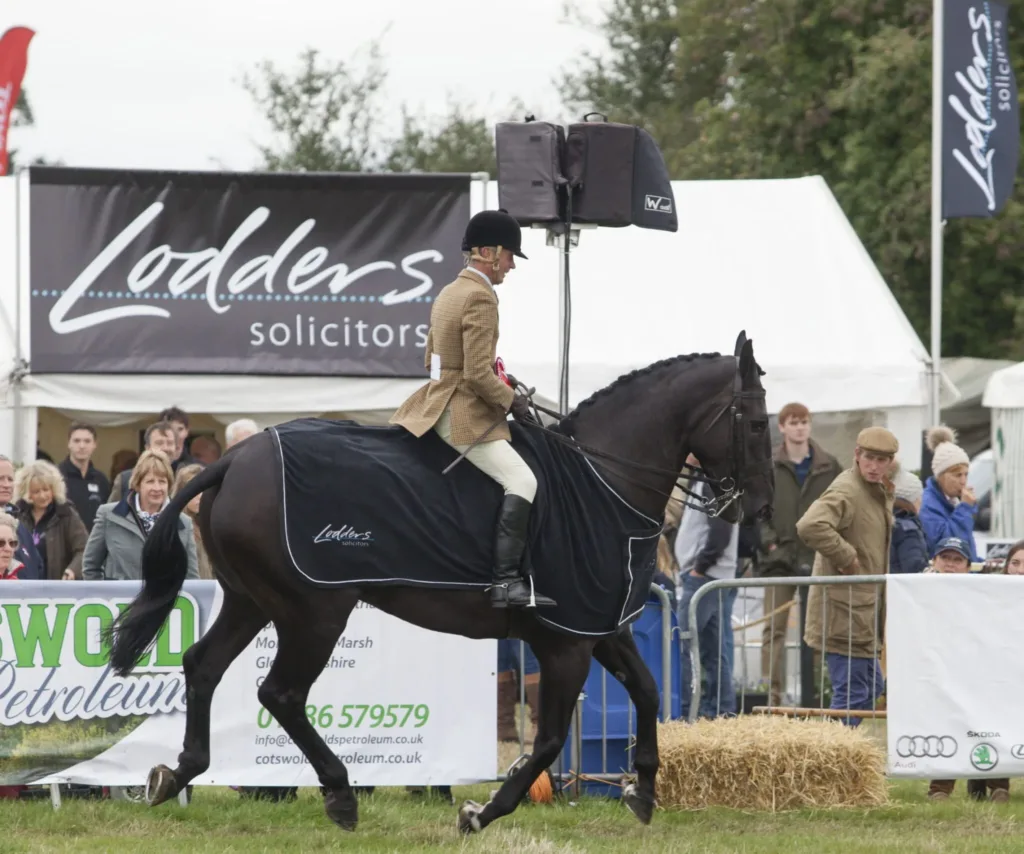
[886,573,1024,779]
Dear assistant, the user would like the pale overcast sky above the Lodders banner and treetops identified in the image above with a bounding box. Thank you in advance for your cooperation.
[6,0,606,170]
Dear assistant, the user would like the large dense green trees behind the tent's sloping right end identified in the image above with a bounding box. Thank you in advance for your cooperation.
[562,0,1024,357]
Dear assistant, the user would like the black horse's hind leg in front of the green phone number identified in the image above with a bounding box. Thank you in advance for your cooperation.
[257,592,358,830]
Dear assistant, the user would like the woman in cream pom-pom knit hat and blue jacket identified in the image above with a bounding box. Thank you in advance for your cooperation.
[921,427,981,562]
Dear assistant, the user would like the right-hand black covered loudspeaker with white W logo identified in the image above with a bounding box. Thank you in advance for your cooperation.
[565,113,679,231]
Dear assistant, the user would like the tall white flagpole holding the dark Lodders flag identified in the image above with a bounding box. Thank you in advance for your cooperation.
[928,0,945,426]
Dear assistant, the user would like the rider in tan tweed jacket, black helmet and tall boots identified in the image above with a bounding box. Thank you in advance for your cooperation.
[391,210,555,608]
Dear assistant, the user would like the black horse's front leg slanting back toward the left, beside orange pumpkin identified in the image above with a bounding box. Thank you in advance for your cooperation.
[458,635,594,834]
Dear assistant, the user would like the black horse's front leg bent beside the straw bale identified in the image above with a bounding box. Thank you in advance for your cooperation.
[594,631,659,824]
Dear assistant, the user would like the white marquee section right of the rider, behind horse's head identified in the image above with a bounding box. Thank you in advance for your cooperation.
[492,176,956,467]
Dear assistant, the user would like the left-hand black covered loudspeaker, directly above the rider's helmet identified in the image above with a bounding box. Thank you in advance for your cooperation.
[495,117,566,225]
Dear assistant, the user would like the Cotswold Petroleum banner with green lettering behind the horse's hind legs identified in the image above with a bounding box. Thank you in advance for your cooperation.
[0,581,498,785]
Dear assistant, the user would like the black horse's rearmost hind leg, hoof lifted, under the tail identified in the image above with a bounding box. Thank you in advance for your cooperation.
[146,588,267,806]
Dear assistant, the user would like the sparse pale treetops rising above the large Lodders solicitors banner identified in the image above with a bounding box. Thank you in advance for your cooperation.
[243,42,496,174]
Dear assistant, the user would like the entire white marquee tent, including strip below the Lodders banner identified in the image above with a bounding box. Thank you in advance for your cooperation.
[0,169,956,467]
